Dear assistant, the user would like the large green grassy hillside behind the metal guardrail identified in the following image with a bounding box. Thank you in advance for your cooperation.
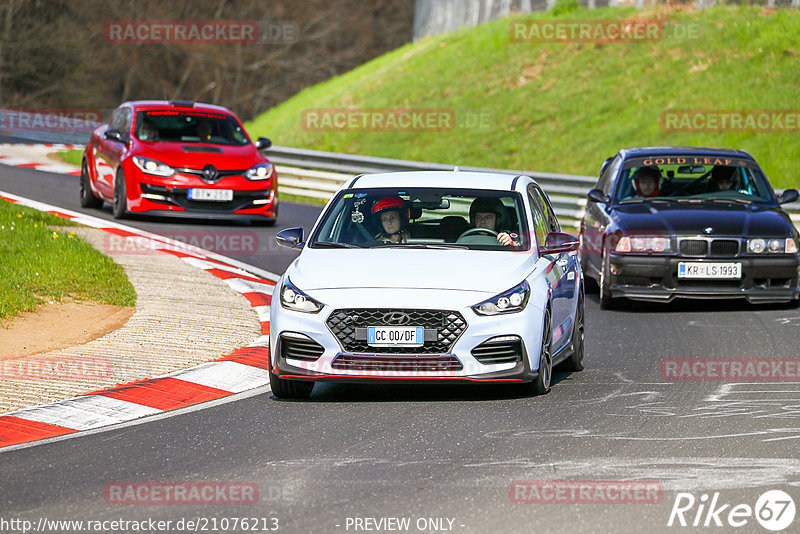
[246,2,800,187]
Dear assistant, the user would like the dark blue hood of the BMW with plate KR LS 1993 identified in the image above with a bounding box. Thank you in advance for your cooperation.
[614,202,792,237]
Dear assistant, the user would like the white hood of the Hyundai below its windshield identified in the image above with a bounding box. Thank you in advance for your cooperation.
[286,248,536,294]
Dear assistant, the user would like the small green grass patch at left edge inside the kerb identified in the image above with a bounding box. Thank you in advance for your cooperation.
[0,200,136,324]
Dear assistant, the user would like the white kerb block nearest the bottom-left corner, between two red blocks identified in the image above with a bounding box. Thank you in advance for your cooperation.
[9,395,161,430]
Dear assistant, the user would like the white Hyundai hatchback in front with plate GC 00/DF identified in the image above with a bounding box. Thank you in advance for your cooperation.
[270,171,584,398]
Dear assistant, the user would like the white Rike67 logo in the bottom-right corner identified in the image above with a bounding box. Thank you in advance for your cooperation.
[667,490,796,532]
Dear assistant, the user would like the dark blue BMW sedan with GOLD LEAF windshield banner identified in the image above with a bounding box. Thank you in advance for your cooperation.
[579,147,800,308]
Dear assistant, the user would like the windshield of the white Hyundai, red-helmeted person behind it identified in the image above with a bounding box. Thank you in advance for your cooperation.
[309,188,528,250]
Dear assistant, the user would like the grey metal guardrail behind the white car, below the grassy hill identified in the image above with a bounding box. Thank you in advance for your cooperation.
[266,146,800,227]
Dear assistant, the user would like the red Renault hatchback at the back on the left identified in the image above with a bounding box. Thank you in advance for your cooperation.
[80,100,278,226]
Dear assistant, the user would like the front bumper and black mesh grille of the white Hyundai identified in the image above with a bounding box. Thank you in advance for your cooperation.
[270,284,543,383]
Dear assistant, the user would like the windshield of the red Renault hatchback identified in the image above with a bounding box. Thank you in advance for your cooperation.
[135,110,250,146]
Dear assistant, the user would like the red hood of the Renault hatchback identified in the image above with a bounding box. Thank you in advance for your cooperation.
[132,142,267,171]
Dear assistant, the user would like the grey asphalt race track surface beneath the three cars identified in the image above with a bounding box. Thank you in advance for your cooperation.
[0,161,800,533]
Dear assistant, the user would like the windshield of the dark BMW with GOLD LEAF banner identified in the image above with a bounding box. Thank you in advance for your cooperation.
[615,155,775,204]
